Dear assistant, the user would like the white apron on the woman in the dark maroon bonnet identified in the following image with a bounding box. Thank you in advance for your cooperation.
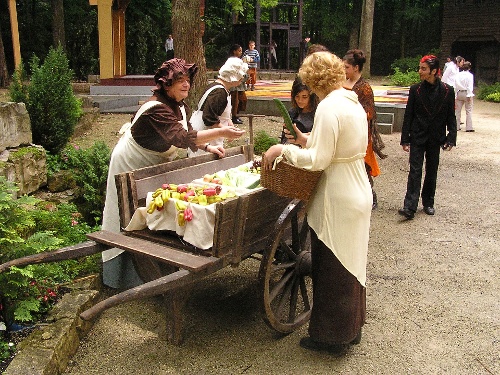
[101,101,187,262]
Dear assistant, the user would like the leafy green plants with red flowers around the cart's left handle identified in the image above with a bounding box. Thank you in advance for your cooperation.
[0,177,99,328]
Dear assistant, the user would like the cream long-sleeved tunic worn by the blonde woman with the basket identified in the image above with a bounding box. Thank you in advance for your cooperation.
[282,88,372,286]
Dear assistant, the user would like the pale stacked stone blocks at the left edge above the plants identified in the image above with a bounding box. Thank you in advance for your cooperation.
[0,102,47,195]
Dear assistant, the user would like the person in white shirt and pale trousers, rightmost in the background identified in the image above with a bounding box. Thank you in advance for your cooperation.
[455,61,474,132]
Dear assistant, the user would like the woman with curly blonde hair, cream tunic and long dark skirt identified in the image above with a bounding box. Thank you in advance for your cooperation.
[263,52,372,355]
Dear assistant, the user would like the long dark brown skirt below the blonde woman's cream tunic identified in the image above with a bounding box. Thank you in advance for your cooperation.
[309,229,366,344]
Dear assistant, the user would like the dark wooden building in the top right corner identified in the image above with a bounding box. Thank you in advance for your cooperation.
[440,0,500,84]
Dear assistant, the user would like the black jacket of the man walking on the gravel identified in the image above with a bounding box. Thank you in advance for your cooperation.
[401,79,457,146]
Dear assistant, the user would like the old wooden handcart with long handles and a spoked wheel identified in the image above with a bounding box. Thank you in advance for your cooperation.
[0,146,312,345]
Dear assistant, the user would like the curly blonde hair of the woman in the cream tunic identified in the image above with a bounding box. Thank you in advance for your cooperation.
[299,51,345,94]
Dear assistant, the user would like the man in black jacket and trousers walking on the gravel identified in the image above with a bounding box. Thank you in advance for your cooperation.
[398,55,457,219]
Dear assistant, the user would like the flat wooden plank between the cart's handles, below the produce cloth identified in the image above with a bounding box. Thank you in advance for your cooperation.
[87,230,219,272]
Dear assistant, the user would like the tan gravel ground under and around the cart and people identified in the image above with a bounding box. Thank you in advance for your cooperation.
[55,101,500,374]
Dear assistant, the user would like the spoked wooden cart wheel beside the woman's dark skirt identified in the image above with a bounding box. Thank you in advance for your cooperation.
[259,200,312,333]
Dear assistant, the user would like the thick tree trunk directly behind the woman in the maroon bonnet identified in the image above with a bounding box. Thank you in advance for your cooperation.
[172,0,208,109]
